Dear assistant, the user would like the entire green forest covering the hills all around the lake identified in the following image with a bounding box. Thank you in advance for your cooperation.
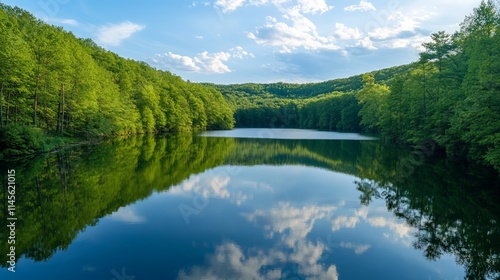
[0,0,500,171]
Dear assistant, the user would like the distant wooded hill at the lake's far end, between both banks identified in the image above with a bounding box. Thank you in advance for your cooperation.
[217,63,415,132]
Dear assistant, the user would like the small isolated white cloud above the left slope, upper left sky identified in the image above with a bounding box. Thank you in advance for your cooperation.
[96,21,145,46]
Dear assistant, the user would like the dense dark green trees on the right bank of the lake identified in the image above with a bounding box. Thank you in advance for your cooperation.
[358,0,500,171]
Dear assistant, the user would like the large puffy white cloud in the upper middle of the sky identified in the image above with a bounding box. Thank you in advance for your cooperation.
[248,7,340,53]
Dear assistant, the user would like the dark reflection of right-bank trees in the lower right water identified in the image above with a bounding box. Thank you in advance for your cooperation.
[358,162,500,279]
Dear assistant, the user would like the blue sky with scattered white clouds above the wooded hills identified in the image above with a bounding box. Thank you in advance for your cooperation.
[0,0,481,84]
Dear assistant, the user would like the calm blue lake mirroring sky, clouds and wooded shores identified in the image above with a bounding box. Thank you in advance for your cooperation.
[0,129,500,280]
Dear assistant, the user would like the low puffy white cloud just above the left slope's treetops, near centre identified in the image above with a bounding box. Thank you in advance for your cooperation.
[150,46,255,74]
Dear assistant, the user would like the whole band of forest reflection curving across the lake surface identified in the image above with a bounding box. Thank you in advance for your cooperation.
[0,134,500,279]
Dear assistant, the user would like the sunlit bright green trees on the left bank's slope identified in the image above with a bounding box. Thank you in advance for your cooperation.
[0,3,234,150]
